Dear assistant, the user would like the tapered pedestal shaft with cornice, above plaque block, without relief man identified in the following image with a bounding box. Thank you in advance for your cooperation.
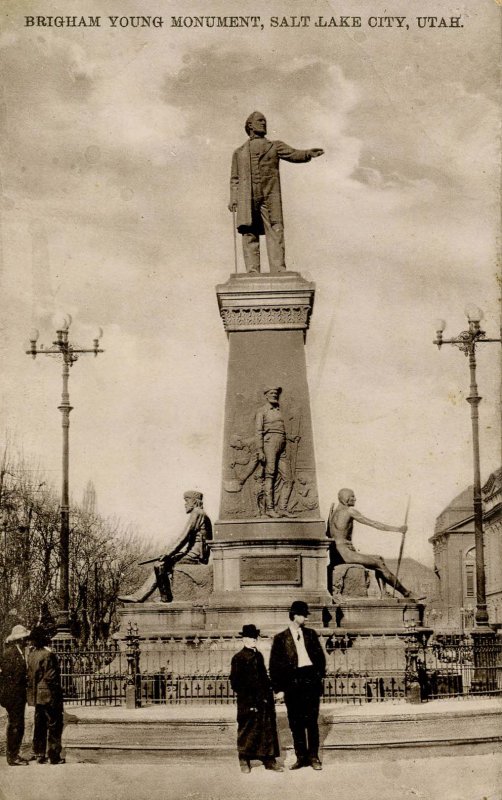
[216,272,319,520]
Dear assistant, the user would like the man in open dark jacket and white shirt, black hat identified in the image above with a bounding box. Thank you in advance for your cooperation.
[270,600,326,770]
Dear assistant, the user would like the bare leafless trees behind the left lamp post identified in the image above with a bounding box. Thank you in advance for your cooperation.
[0,441,153,643]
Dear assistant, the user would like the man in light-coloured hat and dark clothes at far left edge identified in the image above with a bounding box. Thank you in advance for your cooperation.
[0,625,30,767]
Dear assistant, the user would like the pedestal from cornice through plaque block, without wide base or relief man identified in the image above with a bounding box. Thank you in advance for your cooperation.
[207,272,331,629]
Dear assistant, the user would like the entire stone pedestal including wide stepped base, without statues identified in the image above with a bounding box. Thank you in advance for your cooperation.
[117,272,423,647]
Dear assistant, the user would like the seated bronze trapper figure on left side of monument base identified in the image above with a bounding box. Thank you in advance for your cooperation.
[118,491,213,603]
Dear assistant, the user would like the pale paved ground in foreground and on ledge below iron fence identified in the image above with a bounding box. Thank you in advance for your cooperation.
[0,698,502,800]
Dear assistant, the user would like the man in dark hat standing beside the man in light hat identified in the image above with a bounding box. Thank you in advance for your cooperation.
[28,625,65,764]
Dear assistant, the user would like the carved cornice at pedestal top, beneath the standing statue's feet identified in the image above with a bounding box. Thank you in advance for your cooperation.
[216,272,315,334]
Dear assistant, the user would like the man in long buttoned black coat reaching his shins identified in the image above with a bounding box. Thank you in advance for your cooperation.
[230,625,283,772]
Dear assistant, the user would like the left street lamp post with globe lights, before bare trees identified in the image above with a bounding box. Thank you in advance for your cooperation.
[26,315,104,635]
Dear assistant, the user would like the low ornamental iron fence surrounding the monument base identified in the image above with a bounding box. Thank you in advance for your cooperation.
[52,629,502,706]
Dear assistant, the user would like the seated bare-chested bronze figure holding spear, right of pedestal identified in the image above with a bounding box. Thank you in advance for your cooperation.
[326,489,411,598]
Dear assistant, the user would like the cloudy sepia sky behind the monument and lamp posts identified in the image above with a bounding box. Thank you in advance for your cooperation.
[0,0,500,563]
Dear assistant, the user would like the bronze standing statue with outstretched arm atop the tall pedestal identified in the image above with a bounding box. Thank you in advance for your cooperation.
[228,111,324,273]
